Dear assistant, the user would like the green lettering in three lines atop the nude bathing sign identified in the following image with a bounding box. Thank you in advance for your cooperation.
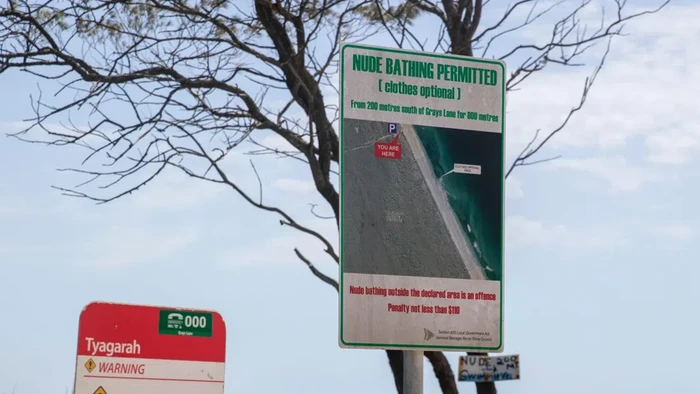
[350,54,499,122]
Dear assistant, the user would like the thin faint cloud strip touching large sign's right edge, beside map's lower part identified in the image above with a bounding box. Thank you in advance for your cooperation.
[506,215,628,250]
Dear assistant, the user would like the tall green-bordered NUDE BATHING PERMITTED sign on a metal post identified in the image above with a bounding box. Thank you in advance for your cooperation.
[339,44,506,352]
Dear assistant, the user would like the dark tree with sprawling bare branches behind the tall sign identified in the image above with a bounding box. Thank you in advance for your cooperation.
[0,0,666,393]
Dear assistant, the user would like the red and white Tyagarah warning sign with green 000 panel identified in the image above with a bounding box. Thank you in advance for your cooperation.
[74,302,226,394]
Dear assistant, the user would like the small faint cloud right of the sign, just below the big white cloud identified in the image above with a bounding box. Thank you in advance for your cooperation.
[550,156,660,192]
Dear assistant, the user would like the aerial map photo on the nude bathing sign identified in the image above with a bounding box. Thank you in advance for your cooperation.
[342,118,503,281]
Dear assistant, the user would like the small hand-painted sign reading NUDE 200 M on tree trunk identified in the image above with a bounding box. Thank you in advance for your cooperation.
[459,354,520,382]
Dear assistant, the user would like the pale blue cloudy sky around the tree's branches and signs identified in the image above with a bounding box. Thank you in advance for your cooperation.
[0,1,700,394]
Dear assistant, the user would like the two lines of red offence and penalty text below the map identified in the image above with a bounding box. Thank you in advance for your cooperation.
[350,286,496,315]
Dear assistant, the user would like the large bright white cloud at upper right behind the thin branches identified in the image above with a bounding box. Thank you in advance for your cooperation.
[508,4,700,164]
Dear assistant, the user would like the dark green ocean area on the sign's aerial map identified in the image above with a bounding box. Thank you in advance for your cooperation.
[414,126,504,280]
